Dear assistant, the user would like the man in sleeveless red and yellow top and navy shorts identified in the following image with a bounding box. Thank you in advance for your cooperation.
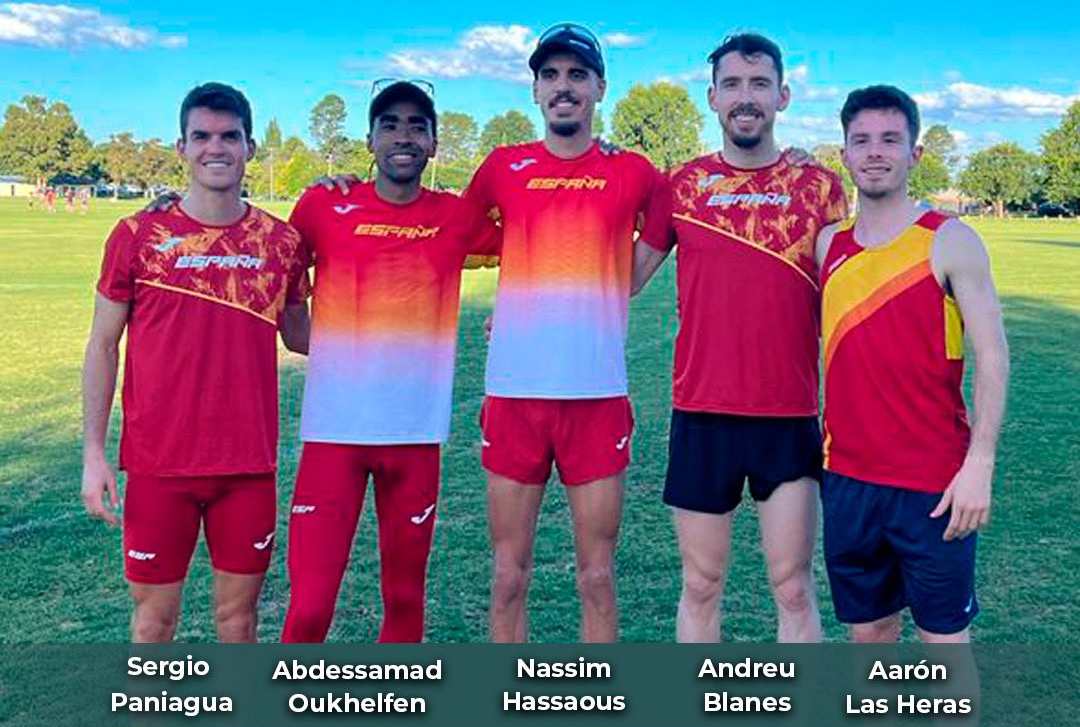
[816,85,1009,643]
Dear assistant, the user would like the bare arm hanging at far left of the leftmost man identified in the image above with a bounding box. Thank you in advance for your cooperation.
[82,293,129,525]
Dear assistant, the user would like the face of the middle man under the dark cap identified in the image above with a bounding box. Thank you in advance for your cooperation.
[532,53,607,136]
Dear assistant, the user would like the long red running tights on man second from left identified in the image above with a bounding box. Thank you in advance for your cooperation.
[281,442,438,643]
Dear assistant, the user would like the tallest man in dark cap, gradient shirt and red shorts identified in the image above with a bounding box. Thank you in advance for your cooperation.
[464,24,670,642]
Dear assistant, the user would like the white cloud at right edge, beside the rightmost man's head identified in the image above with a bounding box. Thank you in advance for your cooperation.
[915,81,1080,122]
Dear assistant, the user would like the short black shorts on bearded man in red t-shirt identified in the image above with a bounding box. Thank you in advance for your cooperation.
[664,409,821,514]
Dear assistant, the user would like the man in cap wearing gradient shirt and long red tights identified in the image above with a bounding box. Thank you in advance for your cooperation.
[282,82,499,642]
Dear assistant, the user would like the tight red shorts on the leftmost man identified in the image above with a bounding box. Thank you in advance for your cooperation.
[124,472,278,583]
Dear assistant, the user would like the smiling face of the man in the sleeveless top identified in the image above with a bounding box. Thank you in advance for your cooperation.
[842,108,922,200]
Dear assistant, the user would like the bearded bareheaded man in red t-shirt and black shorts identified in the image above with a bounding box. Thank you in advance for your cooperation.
[635,33,847,642]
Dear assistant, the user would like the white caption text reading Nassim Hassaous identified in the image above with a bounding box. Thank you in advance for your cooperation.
[502,657,626,712]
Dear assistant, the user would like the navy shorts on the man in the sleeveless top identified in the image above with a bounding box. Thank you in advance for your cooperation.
[821,472,978,634]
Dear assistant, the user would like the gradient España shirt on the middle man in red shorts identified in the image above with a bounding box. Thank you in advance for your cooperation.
[464,142,671,399]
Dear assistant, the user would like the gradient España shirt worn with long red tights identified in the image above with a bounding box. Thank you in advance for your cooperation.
[291,183,499,444]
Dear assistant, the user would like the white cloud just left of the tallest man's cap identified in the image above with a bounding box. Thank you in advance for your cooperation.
[389,25,535,83]
